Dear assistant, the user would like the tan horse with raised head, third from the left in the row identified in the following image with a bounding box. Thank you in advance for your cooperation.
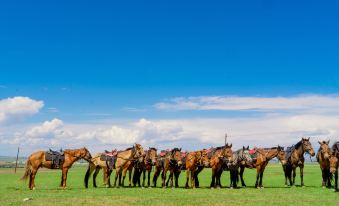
[114,144,145,187]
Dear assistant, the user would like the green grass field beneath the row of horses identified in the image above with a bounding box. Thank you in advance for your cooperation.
[0,164,339,206]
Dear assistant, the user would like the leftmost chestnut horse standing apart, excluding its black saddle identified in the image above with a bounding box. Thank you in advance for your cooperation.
[21,147,92,190]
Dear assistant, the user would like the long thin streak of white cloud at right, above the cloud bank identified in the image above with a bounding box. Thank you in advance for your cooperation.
[155,95,339,113]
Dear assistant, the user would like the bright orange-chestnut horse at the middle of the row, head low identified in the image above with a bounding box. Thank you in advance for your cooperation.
[186,149,210,189]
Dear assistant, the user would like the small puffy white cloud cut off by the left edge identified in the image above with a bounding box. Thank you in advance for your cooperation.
[0,97,44,124]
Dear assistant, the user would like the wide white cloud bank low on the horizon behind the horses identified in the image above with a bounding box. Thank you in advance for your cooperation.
[0,115,339,157]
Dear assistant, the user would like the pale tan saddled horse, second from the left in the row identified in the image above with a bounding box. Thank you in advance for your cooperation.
[84,150,117,188]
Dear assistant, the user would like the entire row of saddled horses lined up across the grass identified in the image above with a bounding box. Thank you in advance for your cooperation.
[22,138,339,191]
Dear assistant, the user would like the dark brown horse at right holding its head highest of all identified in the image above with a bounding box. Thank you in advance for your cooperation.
[283,138,315,187]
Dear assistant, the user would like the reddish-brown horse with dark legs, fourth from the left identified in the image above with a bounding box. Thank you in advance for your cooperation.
[133,147,157,187]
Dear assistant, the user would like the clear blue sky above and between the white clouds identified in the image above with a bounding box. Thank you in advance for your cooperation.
[0,1,339,154]
